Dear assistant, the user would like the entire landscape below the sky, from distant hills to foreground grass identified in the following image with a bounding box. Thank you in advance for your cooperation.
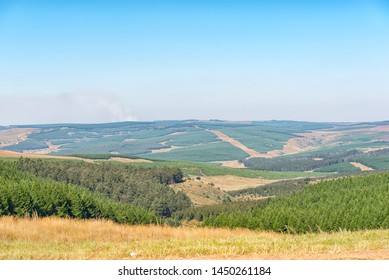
[0,120,389,259]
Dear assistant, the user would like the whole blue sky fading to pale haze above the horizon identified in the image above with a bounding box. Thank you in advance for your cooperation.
[0,0,389,125]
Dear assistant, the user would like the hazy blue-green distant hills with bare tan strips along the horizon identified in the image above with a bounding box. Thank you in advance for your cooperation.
[0,120,389,172]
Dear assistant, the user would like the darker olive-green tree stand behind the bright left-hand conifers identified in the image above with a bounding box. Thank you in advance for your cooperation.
[14,158,192,217]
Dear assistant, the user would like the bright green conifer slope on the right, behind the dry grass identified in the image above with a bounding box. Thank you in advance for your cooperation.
[204,172,389,233]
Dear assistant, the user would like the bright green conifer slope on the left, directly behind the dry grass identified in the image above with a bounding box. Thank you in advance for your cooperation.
[0,160,161,224]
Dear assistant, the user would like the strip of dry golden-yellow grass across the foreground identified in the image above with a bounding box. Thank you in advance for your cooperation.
[0,217,389,260]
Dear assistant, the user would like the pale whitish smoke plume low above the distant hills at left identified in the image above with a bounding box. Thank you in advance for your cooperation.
[0,92,135,125]
